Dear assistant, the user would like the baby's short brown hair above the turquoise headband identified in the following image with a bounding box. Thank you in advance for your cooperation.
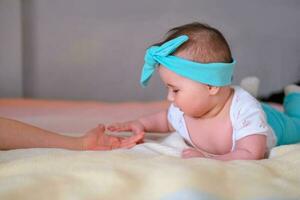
[155,22,233,63]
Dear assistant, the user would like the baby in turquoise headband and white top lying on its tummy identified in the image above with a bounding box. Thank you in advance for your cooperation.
[107,23,300,160]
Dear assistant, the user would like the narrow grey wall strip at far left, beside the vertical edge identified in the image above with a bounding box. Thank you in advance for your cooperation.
[0,0,23,97]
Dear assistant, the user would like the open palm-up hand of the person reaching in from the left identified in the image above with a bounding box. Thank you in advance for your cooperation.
[81,124,142,150]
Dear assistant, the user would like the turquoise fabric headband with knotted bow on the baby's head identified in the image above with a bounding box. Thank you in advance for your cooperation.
[140,35,236,87]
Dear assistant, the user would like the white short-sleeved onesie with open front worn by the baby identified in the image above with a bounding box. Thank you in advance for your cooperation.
[168,86,276,151]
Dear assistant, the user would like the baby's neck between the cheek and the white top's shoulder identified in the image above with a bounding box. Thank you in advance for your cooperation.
[201,87,233,119]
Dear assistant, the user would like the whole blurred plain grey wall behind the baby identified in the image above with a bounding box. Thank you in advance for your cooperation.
[0,0,300,101]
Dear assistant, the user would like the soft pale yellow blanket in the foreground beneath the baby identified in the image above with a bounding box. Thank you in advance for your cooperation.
[0,135,300,200]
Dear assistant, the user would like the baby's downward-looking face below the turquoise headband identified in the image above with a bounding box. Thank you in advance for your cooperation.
[158,66,211,117]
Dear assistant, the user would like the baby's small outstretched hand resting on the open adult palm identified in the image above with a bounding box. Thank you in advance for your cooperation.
[107,120,145,143]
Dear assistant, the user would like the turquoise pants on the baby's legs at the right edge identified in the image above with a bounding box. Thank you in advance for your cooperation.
[262,93,300,146]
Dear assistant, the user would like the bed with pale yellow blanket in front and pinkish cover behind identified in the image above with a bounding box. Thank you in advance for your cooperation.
[0,99,300,200]
